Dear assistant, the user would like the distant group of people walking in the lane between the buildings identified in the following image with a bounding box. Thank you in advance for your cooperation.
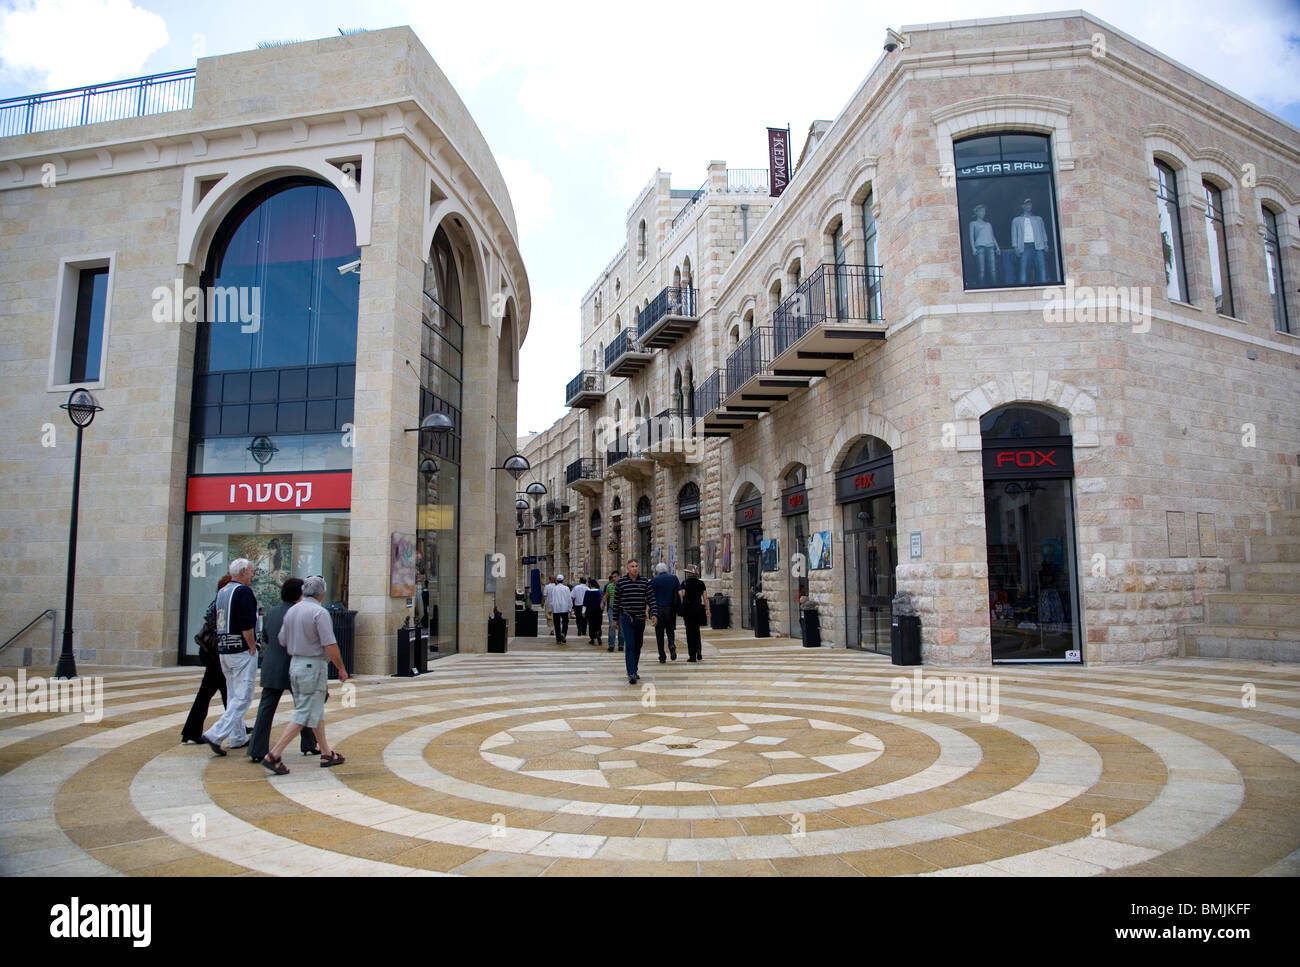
[542,560,709,685]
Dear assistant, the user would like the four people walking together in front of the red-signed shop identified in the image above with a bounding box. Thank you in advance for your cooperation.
[181,558,348,776]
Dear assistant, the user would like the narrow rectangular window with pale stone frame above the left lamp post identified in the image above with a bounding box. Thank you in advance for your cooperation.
[48,255,113,390]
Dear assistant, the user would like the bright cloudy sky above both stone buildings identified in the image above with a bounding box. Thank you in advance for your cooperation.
[0,0,1300,432]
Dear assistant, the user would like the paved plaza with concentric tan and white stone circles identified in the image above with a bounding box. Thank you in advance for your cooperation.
[0,632,1300,876]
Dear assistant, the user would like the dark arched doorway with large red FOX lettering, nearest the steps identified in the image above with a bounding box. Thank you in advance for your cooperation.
[980,403,1083,663]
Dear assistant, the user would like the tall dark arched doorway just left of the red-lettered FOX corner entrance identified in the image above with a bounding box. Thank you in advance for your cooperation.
[835,437,898,652]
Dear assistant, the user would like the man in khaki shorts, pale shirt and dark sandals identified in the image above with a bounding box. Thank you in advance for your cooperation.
[261,576,347,776]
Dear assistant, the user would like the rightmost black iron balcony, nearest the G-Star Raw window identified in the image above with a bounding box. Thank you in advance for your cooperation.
[772,263,884,366]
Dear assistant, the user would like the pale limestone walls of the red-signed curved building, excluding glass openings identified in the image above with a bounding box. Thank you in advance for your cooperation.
[0,27,530,673]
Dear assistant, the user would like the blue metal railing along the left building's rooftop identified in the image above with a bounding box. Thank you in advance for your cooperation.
[0,68,195,138]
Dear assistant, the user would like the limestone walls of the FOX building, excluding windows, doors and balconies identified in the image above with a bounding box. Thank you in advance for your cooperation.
[530,12,1300,665]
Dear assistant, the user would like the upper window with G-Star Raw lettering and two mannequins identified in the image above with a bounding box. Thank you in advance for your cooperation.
[953,131,1061,289]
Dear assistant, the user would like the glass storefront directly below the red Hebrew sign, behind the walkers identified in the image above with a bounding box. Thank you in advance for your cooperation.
[183,511,350,660]
